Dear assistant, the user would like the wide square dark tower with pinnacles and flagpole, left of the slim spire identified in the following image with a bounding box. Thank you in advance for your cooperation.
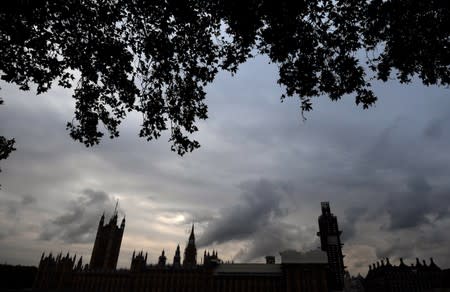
[89,204,125,270]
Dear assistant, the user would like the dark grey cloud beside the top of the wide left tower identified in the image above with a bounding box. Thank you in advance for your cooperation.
[39,189,119,243]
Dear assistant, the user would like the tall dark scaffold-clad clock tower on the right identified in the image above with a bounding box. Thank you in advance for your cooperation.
[317,202,345,291]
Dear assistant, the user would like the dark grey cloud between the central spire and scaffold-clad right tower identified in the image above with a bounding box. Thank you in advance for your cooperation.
[198,179,317,262]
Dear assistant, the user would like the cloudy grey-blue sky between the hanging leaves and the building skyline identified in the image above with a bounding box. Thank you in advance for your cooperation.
[0,56,450,276]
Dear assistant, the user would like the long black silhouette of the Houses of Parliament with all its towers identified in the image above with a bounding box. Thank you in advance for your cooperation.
[29,202,450,292]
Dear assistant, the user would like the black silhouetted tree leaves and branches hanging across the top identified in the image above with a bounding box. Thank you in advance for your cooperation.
[0,0,450,155]
